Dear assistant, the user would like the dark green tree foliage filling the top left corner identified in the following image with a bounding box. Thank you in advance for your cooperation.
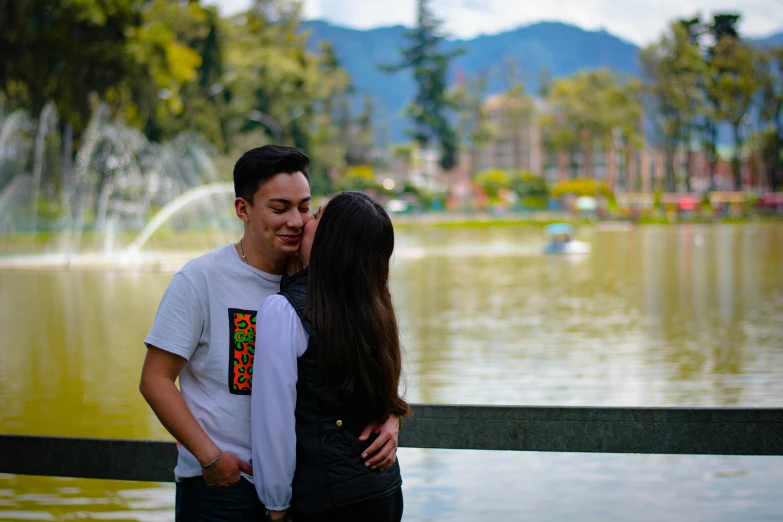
[0,0,144,134]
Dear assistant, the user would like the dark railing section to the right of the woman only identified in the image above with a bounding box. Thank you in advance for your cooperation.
[400,405,783,455]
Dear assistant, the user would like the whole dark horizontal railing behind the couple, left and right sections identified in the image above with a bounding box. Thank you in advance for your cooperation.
[0,404,783,482]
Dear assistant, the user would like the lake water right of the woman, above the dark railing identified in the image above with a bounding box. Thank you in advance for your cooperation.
[392,222,783,406]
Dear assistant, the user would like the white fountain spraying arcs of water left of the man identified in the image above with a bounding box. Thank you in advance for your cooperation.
[0,104,241,268]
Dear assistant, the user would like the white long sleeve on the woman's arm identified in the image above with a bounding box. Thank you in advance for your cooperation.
[250,295,309,511]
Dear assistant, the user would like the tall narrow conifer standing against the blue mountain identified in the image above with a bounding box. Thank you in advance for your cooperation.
[383,0,460,170]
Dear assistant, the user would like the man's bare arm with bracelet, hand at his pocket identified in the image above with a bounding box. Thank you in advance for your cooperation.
[139,345,253,486]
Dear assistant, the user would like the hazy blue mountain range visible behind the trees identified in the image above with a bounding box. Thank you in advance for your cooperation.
[302,20,783,141]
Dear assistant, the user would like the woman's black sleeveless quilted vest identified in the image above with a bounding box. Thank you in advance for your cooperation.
[280,270,402,513]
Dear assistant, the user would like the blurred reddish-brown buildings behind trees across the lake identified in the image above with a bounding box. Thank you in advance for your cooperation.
[395,94,766,193]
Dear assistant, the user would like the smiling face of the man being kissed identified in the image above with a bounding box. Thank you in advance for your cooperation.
[240,172,311,260]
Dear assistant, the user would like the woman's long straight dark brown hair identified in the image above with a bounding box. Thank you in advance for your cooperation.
[307,192,410,421]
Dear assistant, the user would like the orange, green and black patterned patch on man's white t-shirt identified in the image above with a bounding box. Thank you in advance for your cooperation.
[228,308,256,395]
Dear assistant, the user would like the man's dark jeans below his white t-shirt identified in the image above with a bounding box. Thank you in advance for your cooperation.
[175,477,266,522]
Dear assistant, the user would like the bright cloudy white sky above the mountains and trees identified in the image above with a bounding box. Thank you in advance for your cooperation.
[208,0,783,46]
